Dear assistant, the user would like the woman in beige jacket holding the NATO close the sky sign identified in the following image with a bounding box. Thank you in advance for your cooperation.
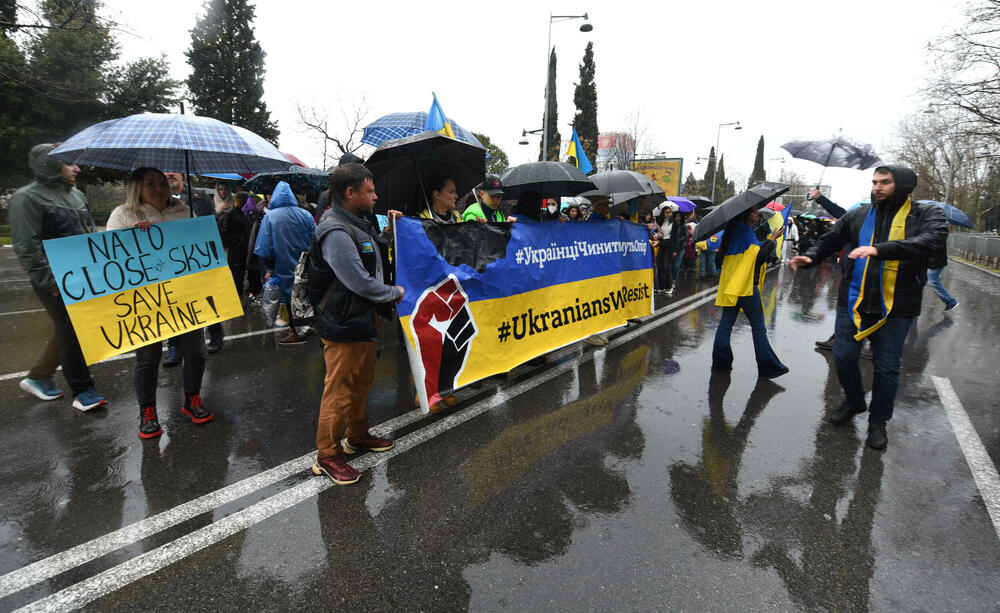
[107,168,212,439]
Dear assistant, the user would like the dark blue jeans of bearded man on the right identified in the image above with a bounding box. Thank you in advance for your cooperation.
[833,306,913,424]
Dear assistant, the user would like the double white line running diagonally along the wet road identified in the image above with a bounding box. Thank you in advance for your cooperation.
[0,287,728,611]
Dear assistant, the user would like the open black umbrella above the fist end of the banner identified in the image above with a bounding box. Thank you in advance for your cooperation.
[365,131,486,215]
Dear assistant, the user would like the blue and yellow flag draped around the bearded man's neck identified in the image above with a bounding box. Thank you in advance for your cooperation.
[847,198,910,341]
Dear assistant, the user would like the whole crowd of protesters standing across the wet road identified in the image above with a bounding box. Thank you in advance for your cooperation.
[11,145,957,484]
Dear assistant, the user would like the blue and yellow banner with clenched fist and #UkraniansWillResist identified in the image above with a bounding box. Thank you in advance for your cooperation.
[396,218,653,411]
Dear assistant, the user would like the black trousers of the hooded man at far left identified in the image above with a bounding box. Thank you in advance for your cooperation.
[28,283,94,396]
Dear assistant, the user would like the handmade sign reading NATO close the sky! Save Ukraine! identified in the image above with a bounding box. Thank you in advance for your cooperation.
[44,217,243,364]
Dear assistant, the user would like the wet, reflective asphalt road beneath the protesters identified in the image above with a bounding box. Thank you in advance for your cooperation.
[0,249,1000,611]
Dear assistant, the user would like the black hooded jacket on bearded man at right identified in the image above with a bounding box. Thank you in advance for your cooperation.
[804,166,948,317]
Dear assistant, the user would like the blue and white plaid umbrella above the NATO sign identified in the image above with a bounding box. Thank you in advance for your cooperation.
[52,113,292,174]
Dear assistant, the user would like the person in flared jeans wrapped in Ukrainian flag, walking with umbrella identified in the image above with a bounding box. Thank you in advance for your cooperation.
[712,209,788,379]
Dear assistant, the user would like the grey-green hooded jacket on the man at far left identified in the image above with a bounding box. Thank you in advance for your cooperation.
[10,144,94,293]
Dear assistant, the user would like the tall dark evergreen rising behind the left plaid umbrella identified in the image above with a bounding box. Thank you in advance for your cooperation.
[186,0,278,143]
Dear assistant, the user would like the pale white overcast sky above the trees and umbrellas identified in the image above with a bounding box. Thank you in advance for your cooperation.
[105,0,965,203]
